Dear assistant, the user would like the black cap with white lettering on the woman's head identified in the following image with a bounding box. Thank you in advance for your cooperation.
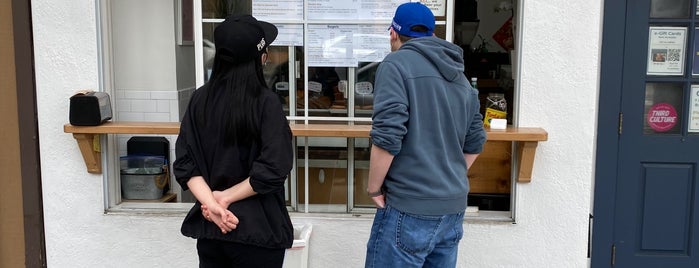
[214,15,278,63]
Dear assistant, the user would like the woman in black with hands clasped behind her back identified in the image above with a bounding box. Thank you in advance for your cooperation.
[173,16,293,267]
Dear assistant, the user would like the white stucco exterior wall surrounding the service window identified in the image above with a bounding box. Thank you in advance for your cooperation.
[32,0,601,267]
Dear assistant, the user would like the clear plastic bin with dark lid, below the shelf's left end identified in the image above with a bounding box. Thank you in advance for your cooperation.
[119,156,168,199]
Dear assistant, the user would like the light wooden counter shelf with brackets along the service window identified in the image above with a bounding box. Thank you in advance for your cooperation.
[63,122,548,182]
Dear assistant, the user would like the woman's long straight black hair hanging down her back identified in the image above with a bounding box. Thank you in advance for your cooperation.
[197,51,267,145]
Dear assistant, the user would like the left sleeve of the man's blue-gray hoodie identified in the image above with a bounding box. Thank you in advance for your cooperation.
[370,61,409,155]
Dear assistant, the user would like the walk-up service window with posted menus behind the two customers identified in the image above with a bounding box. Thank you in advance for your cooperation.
[86,0,546,218]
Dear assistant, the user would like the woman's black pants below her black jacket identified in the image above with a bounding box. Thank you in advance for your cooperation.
[197,239,286,268]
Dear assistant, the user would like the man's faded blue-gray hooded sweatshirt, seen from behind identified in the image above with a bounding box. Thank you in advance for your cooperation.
[371,37,486,215]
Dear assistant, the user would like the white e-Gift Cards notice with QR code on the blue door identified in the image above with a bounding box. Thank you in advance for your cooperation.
[646,27,687,75]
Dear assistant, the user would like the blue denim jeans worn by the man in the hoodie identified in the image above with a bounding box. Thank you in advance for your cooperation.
[364,205,464,268]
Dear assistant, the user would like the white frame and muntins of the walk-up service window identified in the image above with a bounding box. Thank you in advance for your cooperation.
[96,0,524,221]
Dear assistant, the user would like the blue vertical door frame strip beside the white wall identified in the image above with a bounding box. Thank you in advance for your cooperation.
[590,0,626,267]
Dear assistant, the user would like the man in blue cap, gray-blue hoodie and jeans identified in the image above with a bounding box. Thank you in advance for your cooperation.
[365,3,486,267]
